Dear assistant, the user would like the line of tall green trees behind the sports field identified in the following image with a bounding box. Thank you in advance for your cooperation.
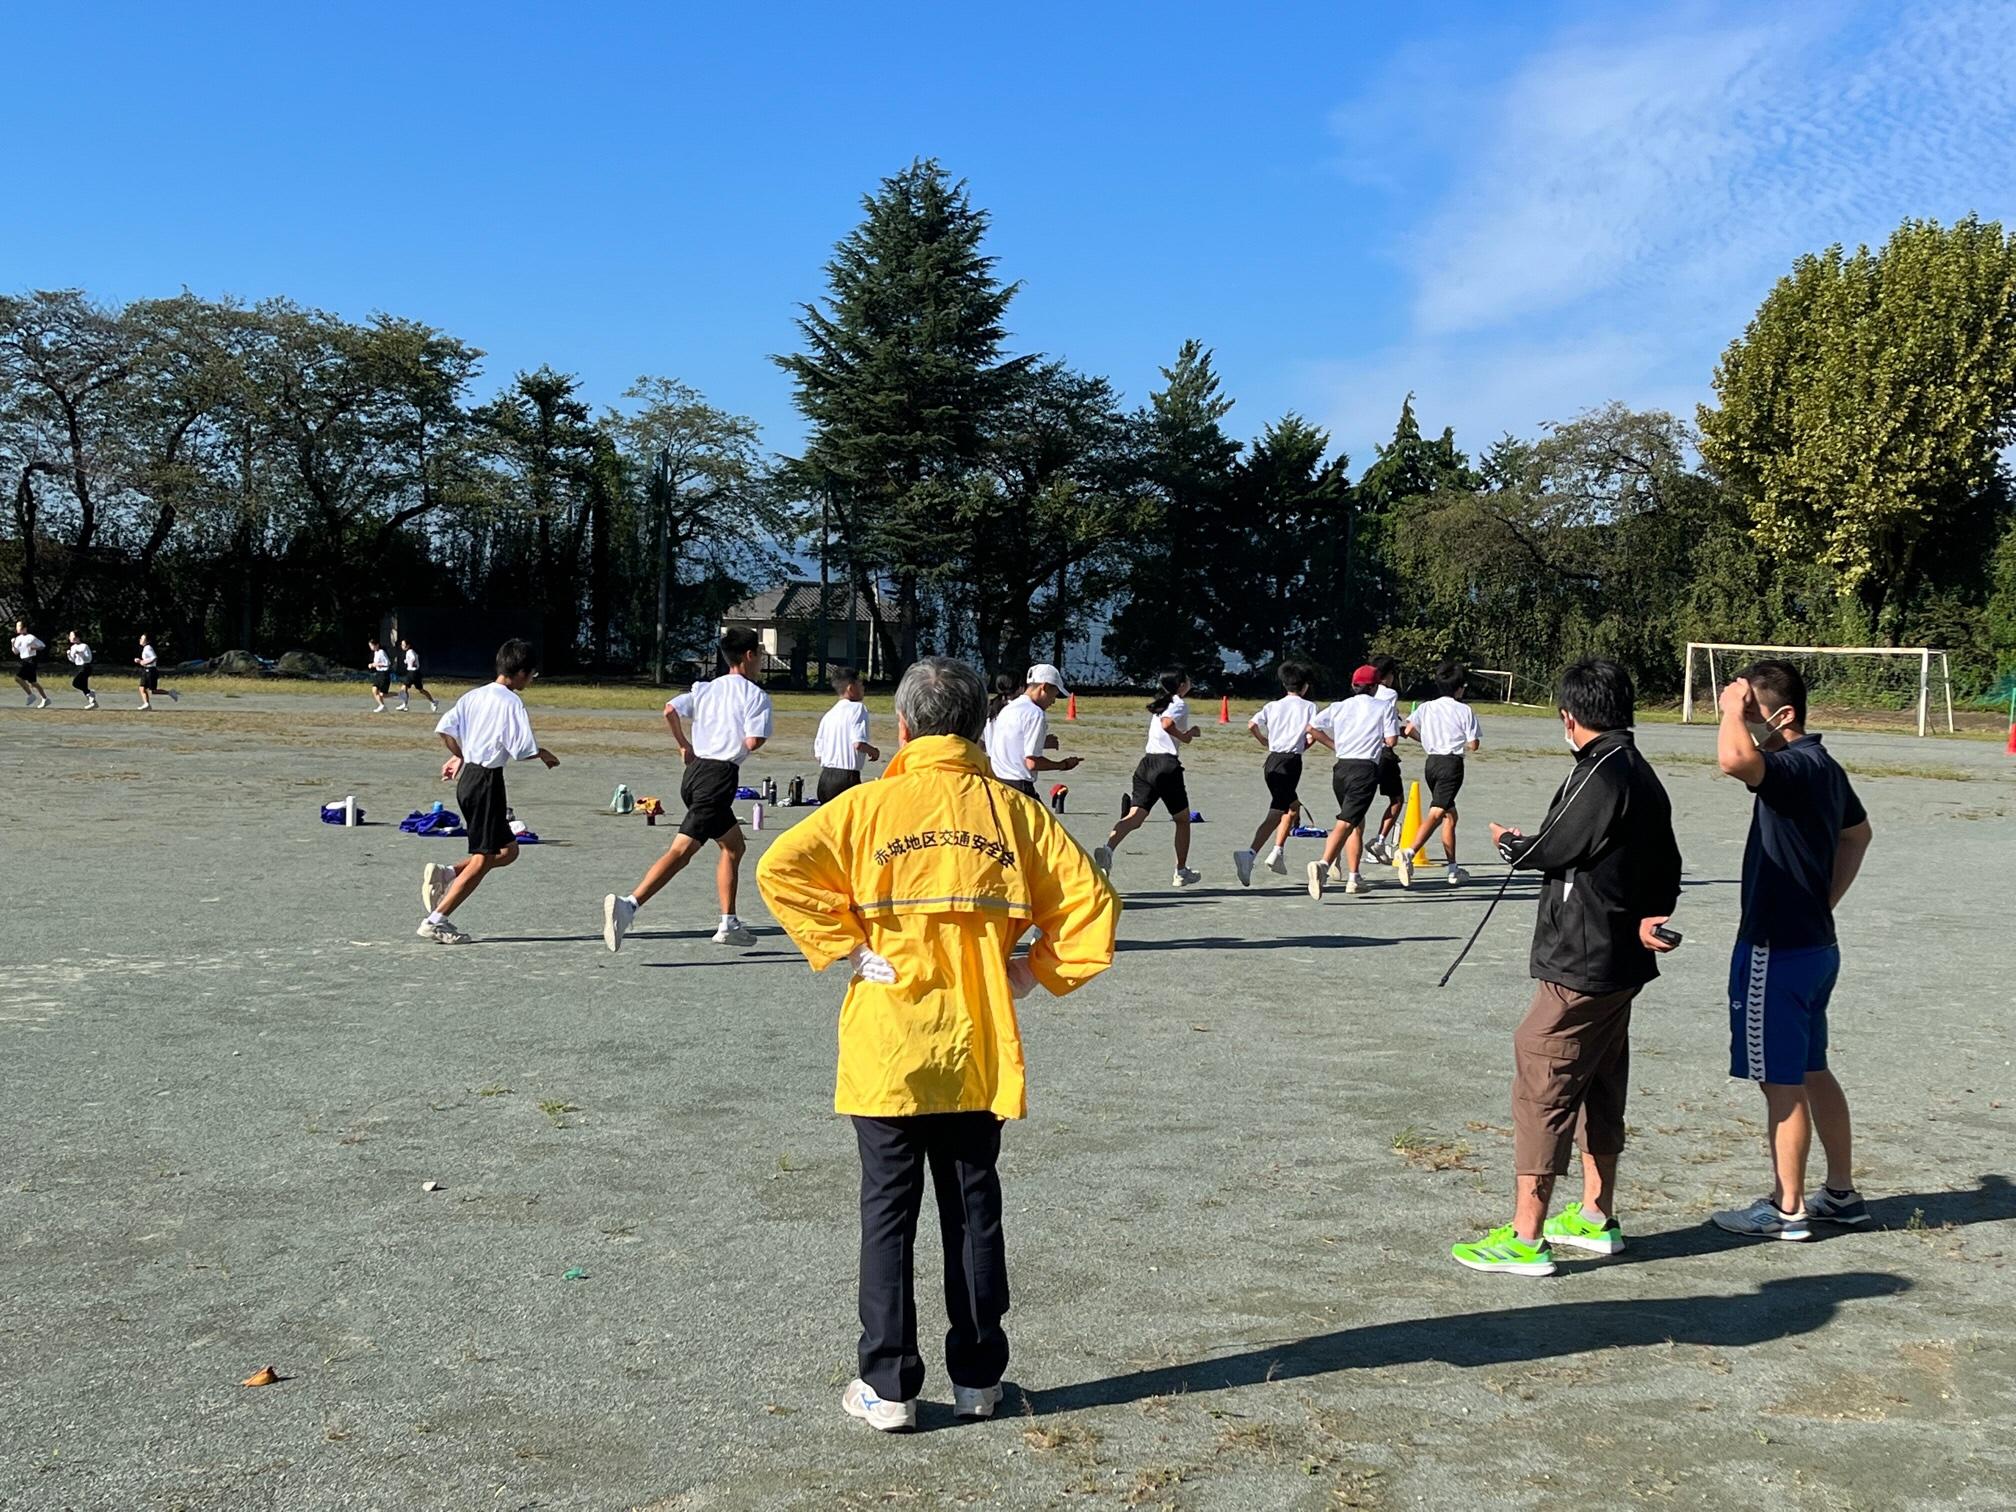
[0,161,2016,691]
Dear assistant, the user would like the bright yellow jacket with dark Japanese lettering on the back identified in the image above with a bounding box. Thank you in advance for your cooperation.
[756,736,1121,1119]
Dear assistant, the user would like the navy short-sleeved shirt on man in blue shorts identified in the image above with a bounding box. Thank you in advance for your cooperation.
[1738,736,1869,950]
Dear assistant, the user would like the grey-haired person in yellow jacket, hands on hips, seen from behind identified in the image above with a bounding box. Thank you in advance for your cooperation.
[756,657,1121,1431]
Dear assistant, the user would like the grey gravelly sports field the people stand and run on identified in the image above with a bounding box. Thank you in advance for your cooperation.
[0,681,2016,1512]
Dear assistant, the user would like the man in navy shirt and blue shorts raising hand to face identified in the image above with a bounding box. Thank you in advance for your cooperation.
[1716,661,1871,1240]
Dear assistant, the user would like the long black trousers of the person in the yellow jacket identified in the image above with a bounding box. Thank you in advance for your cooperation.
[855,1113,1008,1401]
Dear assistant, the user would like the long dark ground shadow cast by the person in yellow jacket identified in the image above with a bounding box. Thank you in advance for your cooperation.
[1022,1270,1911,1415]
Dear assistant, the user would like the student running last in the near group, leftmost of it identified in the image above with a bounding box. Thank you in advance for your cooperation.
[413,641,560,946]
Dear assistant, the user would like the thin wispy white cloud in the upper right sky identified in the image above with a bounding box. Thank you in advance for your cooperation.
[1308,0,2016,467]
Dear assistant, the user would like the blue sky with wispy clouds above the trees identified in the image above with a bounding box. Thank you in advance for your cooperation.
[0,0,2016,468]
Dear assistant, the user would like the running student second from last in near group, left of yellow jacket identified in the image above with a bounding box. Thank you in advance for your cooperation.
[603,629,772,952]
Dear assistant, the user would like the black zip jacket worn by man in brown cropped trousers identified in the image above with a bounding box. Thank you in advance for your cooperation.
[1498,730,1679,994]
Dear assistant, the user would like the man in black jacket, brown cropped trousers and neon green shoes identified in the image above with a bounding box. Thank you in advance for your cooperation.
[1450,659,1679,1276]
